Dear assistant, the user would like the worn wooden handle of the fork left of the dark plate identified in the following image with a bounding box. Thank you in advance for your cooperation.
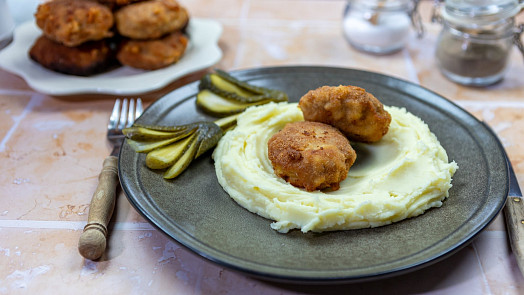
[78,156,118,260]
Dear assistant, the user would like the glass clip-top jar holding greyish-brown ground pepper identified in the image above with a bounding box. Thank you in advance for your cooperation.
[436,0,524,86]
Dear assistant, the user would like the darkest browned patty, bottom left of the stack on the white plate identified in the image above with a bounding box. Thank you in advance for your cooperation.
[29,36,116,76]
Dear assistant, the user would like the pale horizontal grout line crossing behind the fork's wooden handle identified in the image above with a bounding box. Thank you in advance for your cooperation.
[0,220,155,230]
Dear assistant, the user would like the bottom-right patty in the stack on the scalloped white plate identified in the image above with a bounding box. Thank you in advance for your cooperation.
[117,32,188,70]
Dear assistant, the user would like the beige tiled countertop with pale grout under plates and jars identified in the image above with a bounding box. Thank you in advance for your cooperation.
[0,0,524,294]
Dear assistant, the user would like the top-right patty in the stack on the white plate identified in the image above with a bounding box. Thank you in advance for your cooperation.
[115,0,189,39]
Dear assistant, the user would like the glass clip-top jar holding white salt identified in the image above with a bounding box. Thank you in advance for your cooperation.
[342,0,423,54]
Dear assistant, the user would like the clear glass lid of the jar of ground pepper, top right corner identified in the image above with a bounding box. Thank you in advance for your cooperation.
[441,0,524,25]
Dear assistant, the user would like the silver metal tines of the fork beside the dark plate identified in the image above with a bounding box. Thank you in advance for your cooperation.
[107,98,143,130]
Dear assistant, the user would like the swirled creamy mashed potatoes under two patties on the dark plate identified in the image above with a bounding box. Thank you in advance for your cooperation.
[213,103,458,233]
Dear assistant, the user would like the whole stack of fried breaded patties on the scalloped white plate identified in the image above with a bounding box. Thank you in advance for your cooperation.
[29,0,189,76]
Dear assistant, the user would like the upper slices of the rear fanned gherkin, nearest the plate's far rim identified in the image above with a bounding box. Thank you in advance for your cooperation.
[199,70,288,103]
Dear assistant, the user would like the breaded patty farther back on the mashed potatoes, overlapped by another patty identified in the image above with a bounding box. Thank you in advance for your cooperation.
[299,86,391,143]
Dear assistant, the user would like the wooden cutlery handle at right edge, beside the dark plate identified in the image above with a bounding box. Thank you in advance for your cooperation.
[504,196,524,274]
